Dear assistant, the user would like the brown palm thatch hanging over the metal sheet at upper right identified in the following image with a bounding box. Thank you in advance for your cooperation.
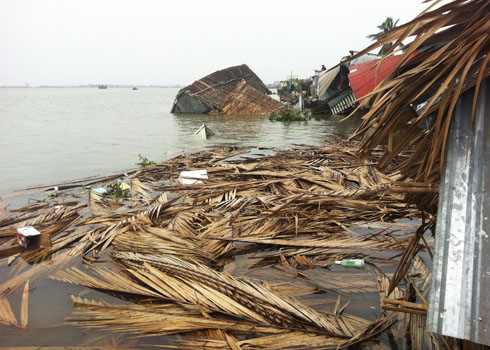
[342,0,490,213]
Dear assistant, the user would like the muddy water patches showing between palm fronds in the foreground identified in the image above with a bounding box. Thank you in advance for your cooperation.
[0,221,419,349]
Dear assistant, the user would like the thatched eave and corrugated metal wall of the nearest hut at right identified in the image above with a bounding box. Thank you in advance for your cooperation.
[342,0,490,349]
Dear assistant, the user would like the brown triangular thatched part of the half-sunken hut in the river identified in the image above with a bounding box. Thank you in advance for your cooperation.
[212,81,286,115]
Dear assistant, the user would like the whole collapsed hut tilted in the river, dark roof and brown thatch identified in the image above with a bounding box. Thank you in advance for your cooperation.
[170,64,282,115]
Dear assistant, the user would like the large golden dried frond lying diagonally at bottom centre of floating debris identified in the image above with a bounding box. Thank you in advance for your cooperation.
[115,253,345,337]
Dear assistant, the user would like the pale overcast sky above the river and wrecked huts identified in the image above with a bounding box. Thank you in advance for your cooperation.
[0,0,427,86]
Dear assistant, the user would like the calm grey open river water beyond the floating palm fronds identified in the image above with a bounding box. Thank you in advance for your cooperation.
[0,88,356,194]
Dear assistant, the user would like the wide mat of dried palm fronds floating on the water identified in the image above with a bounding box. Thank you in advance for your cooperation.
[0,139,437,349]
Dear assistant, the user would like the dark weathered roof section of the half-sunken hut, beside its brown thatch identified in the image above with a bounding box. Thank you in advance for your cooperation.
[170,64,271,114]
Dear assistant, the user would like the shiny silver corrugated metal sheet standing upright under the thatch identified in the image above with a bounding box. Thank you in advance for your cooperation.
[427,79,490,345]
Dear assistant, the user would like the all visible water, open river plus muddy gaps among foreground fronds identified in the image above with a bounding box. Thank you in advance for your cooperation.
[0,89,416,348]
